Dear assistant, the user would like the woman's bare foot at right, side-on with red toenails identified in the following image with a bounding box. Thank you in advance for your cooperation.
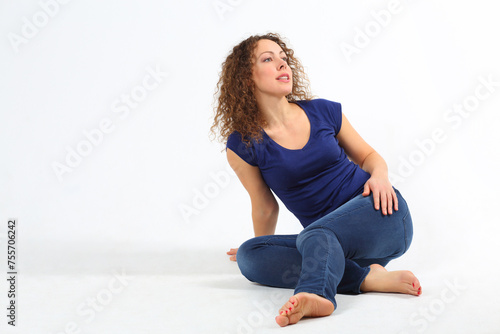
[361,264,422,296]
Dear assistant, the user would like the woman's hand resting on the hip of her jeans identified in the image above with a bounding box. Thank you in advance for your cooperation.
[363,175,398,215]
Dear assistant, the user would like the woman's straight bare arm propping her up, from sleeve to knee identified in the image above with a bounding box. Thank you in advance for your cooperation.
[226,148,279,252]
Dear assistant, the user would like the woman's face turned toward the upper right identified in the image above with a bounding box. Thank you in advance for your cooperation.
[252,39,293,98]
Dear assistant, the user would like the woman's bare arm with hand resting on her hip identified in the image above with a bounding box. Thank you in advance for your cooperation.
[337,114,398,215]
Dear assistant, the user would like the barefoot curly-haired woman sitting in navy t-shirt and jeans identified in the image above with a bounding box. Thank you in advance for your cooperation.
[212,34,422,326]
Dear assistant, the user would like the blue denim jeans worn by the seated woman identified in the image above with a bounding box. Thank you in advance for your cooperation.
[237,190,413,309]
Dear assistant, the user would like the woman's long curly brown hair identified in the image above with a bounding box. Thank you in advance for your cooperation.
[210,33,312,145]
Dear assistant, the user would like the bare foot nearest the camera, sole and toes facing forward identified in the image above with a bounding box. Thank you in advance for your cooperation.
[276,292,335,327]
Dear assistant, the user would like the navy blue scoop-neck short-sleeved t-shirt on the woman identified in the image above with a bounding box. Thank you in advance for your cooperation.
[227,99,370,227]
